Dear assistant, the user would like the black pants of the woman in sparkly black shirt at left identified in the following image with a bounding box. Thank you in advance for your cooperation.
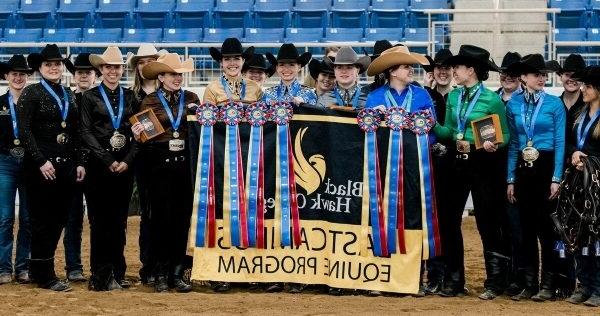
[25,158,77,287]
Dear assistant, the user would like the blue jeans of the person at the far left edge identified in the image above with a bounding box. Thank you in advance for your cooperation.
[0,154,31,274]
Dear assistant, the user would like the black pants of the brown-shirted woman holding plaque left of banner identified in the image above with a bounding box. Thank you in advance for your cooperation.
[149,150,193,276]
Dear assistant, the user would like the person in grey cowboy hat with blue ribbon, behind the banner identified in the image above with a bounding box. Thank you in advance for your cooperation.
[317,46,371,111]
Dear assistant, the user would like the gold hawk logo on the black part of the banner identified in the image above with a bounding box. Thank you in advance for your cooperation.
[294,127,327,195]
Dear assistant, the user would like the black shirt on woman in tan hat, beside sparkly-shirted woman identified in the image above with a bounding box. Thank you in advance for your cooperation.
[80,83,138,166]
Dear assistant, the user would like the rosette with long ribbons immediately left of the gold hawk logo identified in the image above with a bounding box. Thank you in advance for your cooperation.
[270,102,302,246]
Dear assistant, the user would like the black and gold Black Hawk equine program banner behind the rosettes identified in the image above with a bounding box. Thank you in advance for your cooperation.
[188,108,427,293]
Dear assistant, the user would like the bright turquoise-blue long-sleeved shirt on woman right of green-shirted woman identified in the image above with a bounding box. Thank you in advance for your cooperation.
[506,92,567,183]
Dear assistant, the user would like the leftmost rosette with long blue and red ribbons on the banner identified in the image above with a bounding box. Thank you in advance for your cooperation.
[194,103,219,248]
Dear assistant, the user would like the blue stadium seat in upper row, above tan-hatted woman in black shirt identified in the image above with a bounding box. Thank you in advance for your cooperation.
[96,0,135,28]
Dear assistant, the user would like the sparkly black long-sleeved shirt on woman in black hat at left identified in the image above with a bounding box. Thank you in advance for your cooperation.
[17,81,84,167]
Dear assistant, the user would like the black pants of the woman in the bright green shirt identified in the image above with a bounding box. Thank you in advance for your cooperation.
[440,147,510,291]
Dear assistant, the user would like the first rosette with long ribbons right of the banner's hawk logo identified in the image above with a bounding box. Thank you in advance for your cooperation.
[357,109,388,257]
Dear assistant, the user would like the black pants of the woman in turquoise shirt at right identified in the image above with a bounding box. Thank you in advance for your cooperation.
[515,152,560,291]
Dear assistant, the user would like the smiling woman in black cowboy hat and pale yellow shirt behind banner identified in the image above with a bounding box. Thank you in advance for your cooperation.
[202,37,262,106]
